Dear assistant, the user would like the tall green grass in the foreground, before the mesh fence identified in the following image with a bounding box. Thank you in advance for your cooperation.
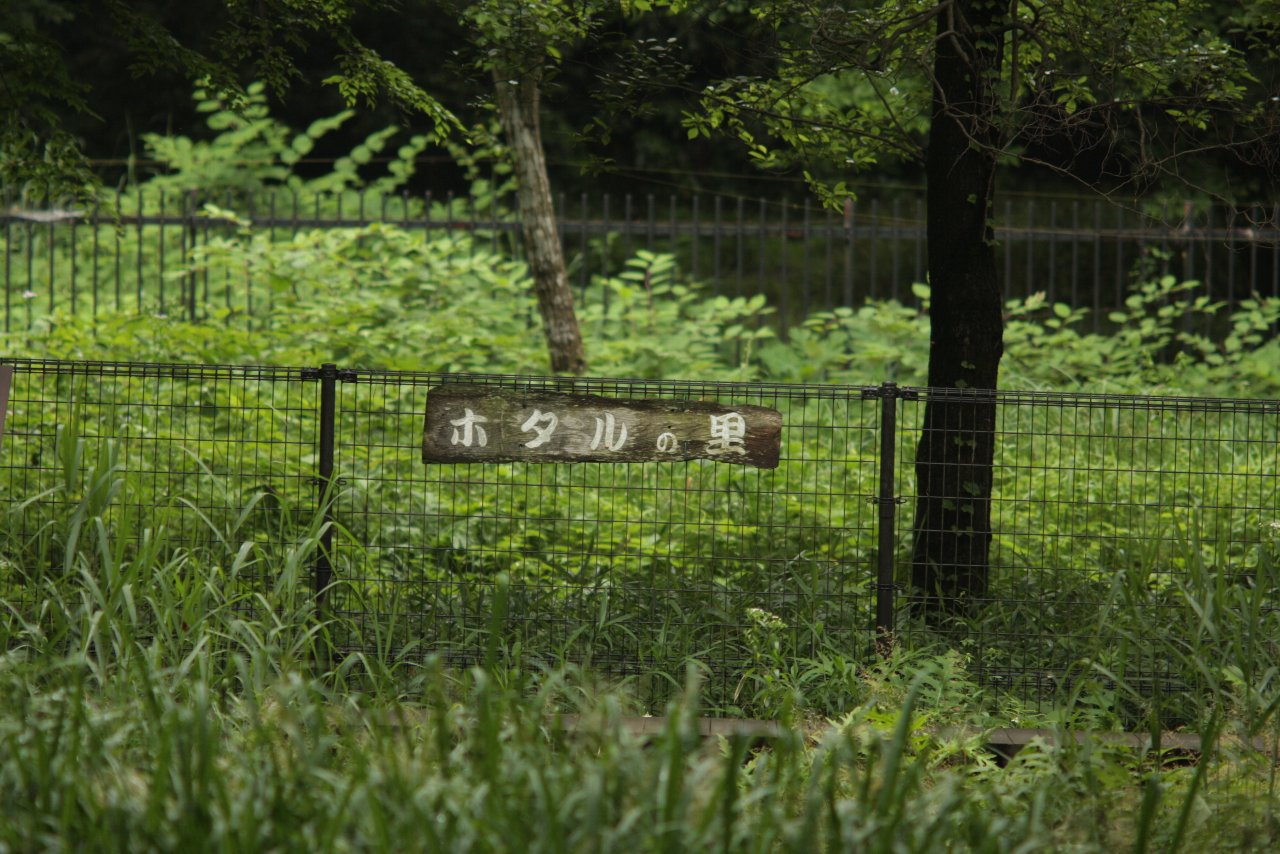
[0,496,1276,851]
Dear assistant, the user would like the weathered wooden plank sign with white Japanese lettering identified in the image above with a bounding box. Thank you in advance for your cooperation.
[422,383,782,469]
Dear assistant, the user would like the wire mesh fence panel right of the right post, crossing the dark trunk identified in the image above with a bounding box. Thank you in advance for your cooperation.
[897,389,1280,699]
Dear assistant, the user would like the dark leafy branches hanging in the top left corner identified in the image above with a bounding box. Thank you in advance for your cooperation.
[0,0,462,195]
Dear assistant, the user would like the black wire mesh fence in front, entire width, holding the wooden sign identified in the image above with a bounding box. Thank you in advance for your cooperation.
[0,360,1280,708]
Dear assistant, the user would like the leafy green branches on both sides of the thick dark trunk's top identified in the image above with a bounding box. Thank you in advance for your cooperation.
[671,0,1275,204]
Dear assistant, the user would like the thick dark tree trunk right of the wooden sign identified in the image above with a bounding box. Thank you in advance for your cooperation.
[911,0,1007,624]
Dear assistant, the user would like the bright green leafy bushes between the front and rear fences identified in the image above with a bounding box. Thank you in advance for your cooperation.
[17,217,1280,397]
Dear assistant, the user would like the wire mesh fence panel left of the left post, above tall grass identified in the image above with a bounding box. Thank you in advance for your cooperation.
[0,361,317,627]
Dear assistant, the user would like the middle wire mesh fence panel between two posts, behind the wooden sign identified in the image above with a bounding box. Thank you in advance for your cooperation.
[332,371,877,697]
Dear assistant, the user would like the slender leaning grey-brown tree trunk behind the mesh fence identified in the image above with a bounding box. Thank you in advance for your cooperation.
[494,70,586,374]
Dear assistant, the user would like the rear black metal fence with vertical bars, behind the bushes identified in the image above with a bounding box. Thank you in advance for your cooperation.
[0,189,1280,330]
